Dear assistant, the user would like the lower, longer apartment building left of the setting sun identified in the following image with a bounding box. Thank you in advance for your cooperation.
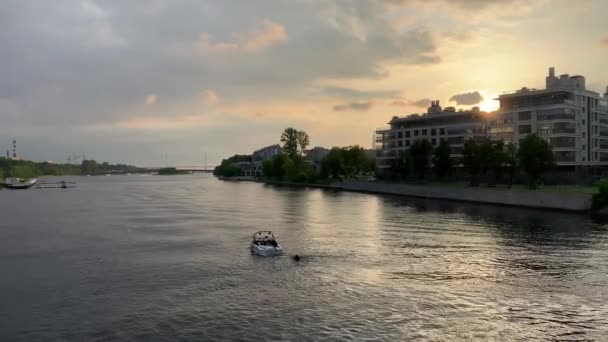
[376,100,492,169]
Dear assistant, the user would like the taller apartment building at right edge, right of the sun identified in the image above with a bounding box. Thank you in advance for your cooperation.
[489,68,608,169]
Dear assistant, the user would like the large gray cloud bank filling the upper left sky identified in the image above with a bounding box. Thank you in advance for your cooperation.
[0,0,439,125]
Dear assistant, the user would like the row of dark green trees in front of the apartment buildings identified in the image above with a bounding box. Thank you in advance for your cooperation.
[390,134,555,189]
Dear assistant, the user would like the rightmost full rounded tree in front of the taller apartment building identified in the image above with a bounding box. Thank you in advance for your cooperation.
[517,134,555,189]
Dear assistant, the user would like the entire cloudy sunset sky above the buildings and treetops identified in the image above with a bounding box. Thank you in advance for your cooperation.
[0,0,608,166]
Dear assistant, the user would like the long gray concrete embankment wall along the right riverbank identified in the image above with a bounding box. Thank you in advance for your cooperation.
[335,181,591,211]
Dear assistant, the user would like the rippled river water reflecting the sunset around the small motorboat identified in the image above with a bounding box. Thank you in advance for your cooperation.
[0,175,608,341]
